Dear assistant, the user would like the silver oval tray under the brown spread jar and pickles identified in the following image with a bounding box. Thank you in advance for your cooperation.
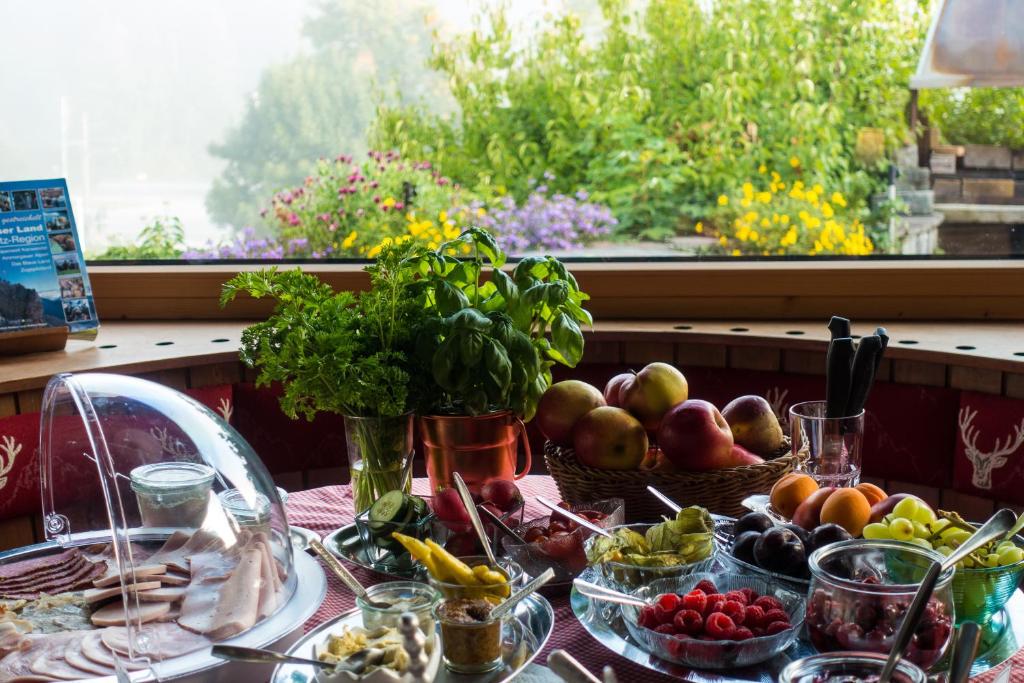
[270,593,555,683]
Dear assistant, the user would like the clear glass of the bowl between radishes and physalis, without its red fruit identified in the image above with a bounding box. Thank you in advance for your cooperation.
[502,498,626,584]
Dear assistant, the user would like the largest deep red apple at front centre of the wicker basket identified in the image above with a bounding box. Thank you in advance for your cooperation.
[657,398,733,472]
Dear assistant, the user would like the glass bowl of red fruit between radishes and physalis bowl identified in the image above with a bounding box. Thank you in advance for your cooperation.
[502,498,626,586]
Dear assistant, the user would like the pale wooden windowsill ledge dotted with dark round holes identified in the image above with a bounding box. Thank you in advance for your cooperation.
[0,319,1024,394]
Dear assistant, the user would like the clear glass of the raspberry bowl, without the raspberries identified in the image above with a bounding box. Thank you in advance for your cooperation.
[620,573,806,669]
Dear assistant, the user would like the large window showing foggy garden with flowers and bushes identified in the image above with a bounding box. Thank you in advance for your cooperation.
[0,0,1024,262]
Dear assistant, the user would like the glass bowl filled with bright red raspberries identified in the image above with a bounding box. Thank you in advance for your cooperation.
[622,573,805,669]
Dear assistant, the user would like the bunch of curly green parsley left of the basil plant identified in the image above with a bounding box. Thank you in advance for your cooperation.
[221,242,426,420]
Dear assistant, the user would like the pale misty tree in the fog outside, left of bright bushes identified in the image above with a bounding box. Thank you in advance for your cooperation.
[207,0,446,227]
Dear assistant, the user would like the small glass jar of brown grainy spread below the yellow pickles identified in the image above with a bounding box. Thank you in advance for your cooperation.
[434,598,504,674]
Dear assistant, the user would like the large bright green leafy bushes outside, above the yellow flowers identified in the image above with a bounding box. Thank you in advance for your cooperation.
[372,0,925,238]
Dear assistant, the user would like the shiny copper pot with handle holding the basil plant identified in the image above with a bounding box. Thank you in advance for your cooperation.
[420,411,531,493]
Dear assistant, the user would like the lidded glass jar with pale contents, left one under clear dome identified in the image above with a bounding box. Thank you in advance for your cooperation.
[131,462,214,528]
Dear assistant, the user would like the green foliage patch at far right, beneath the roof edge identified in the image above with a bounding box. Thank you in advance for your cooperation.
[921,88,1024,147]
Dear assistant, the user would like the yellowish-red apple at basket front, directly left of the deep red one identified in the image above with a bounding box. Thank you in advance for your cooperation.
[572,405,647,470]
